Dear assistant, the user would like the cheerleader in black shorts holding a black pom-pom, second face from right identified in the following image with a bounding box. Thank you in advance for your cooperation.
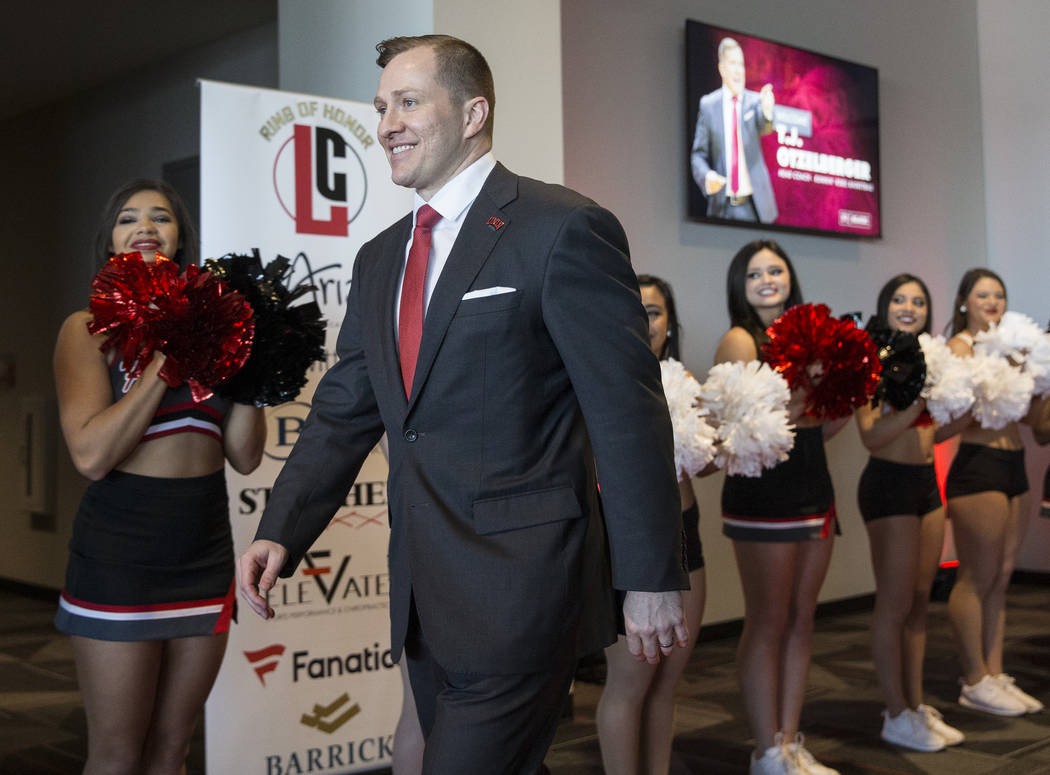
[856,274,963,751]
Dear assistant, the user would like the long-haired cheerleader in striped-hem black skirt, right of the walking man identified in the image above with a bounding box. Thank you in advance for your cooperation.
[715,240,848,775]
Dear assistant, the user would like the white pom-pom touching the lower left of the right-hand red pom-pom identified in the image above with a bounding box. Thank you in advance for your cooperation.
[700,360,795,477]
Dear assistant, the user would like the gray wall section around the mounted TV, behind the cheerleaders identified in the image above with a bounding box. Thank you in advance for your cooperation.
[562,0,999,622]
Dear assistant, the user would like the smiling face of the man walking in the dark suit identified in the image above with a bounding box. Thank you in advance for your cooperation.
[374,46,488,201]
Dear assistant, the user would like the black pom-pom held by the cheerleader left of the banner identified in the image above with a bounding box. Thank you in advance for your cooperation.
[205,250,324,406]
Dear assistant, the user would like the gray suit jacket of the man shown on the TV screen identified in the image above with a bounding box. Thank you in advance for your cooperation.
[690,88,778,224]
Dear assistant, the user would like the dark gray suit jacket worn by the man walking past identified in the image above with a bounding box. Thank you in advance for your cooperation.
[251,165,688,674]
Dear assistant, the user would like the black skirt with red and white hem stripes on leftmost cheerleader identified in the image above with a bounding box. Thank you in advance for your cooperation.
[55,470,235,641]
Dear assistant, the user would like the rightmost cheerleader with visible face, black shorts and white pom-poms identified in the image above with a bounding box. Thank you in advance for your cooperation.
[945,269,1043,716]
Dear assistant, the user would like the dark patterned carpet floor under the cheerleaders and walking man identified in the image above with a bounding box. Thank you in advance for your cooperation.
[0,583,1050,775]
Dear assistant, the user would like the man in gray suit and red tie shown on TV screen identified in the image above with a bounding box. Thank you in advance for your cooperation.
[691,38,777,224]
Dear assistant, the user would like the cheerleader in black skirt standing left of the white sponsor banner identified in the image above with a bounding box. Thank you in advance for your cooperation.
[55,181,266,775]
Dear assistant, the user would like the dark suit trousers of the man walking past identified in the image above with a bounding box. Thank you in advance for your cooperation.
[405,603,576,775]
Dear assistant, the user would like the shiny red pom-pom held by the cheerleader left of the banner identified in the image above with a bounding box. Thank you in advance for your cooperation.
[87,253,254,401]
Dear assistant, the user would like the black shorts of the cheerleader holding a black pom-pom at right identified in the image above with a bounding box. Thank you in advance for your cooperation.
[857,458,943,522]
